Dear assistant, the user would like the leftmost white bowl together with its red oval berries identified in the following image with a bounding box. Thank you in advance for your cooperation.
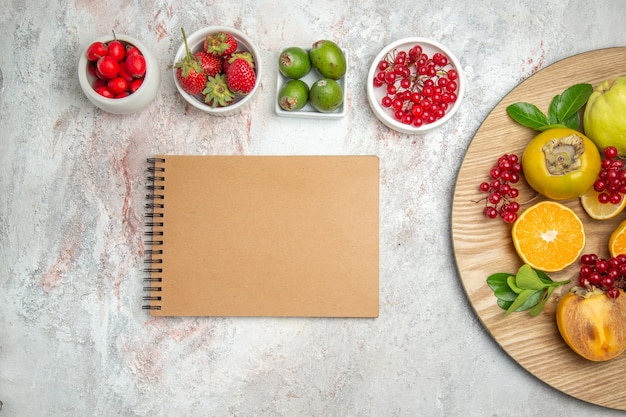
[78,33,161,114]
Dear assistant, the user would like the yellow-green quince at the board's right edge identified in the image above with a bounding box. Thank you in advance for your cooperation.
[583,76,626,157]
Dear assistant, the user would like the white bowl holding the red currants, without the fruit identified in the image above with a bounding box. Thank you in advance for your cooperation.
[367,37,466,134]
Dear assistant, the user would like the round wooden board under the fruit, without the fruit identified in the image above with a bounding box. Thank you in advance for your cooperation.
[452,47,626,410]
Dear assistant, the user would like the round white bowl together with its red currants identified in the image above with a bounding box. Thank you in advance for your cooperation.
[367,37,465,134]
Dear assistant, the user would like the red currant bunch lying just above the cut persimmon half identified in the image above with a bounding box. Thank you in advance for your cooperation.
[578,254,626,299]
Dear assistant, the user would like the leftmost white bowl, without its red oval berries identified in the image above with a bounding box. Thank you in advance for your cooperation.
[78,34,161,114]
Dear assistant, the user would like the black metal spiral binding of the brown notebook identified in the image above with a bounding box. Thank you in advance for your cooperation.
[142,158,165,310]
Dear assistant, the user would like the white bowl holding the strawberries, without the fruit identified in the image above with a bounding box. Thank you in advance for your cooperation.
[172,26,262,116]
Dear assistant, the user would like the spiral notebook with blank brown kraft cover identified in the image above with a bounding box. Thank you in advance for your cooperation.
[144,155,379,317]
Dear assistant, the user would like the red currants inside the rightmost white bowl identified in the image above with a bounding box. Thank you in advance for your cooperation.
[373,45,459,127]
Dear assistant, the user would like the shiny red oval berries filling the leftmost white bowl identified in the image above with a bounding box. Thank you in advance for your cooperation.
[87,35,146,98]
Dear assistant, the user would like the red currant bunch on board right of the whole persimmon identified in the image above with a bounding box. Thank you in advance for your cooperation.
[593,146,626,204]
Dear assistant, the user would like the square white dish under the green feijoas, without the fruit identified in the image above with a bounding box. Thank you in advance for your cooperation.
[274,48,349,120]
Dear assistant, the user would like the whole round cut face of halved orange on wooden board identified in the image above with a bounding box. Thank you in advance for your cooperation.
[512,200,585,272]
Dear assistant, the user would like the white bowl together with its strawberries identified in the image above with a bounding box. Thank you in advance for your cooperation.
[172,26,261,116]
